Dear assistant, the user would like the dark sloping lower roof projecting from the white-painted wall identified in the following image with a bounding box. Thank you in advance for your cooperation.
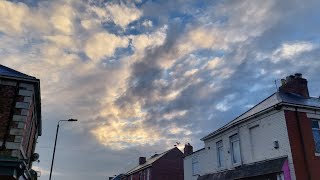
[197,157,287,180]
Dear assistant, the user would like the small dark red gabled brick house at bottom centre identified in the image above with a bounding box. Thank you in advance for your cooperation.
[122,147,183,180]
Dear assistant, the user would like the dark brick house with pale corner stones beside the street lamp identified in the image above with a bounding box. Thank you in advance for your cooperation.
[0,65,41,180]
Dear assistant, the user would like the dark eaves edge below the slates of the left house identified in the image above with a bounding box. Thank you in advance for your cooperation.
[0,73,42,136]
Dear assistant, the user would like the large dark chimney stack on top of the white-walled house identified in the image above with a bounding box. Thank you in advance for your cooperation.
[279,73,310,98]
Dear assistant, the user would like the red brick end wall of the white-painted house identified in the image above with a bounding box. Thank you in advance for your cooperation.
[285,111,320,180]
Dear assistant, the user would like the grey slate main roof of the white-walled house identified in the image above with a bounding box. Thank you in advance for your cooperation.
[201,91,320,141]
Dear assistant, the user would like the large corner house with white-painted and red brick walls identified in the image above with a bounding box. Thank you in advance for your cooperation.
[184,74,320,180]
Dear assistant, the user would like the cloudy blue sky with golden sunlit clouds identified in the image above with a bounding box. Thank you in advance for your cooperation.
[0,0,320,180]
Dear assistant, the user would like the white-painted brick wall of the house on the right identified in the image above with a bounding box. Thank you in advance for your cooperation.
[184,111,296,180]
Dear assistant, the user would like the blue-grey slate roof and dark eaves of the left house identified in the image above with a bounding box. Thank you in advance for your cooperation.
[0,64,42,136]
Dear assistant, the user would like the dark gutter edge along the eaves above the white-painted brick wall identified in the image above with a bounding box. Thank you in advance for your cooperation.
[200,100,320,141]
